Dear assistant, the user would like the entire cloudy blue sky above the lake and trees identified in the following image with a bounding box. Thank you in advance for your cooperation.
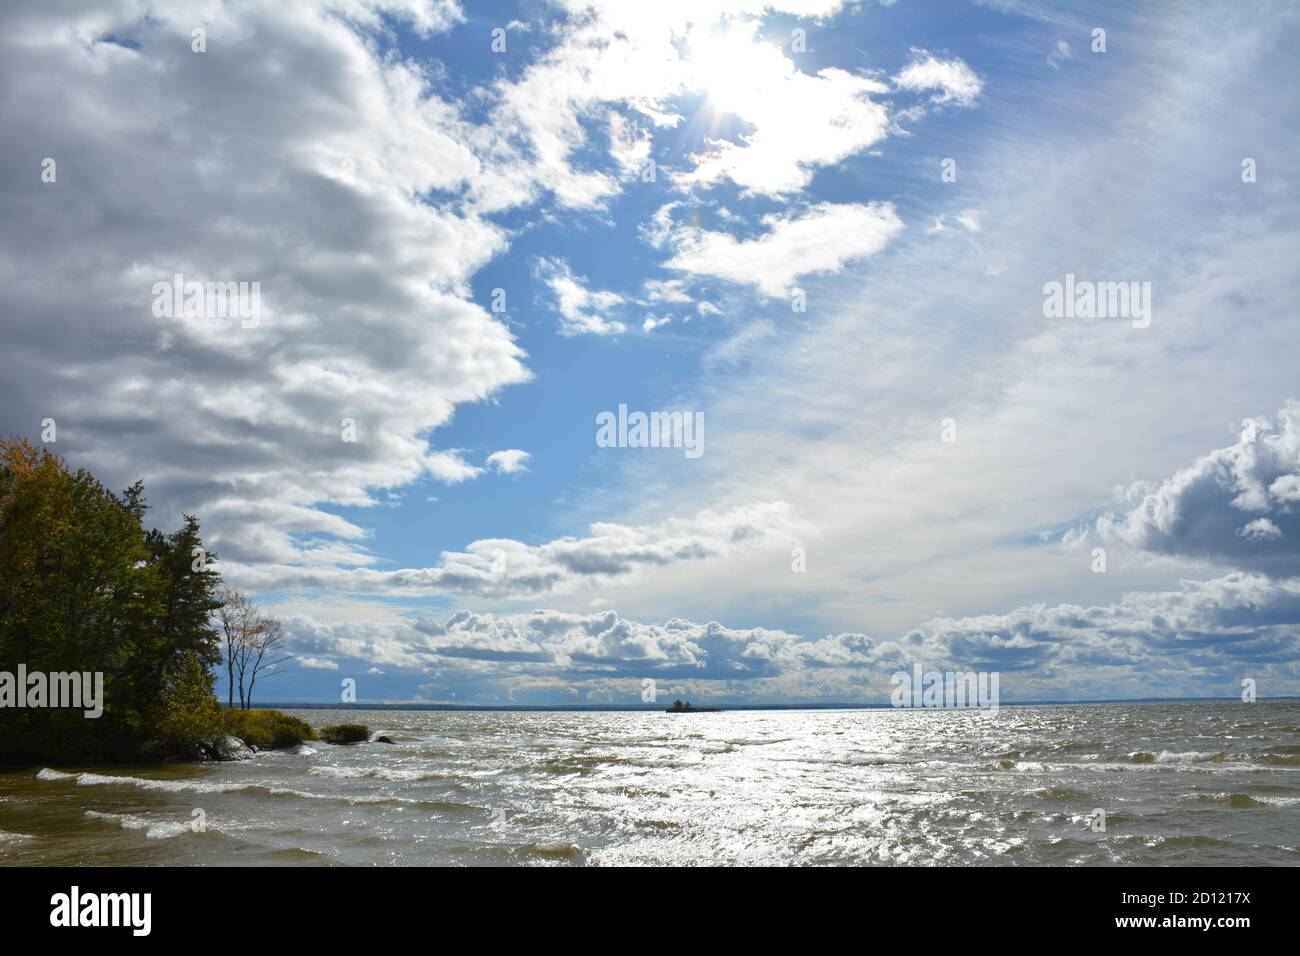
[0,0,1300,706]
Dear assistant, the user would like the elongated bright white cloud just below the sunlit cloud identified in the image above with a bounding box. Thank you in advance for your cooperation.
[662,203,902,297]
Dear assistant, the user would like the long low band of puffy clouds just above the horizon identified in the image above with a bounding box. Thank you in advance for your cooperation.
[276,574,1300,701]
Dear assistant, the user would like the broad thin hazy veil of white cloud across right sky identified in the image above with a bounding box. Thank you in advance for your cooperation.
[585,1,1300,650]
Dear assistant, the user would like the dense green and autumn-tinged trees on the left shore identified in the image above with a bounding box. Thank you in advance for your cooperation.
[0,440,221,762]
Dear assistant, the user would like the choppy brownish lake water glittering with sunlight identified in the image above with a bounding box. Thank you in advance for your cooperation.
[0,702,1300,866]
